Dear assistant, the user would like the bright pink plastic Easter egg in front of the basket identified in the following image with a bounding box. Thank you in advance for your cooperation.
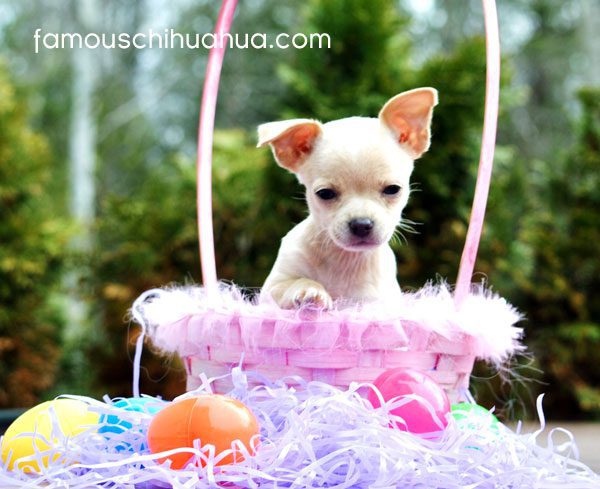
[368,368,450,438]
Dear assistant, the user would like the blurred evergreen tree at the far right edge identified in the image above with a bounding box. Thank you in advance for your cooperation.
[524,88,600,418]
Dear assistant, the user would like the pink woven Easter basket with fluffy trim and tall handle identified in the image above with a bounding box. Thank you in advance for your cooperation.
[133,0,522,401]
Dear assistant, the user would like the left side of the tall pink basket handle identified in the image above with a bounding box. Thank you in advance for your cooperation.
[196,0,237,297]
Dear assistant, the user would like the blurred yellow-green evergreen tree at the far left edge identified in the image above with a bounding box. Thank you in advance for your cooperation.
[0,65,67,407]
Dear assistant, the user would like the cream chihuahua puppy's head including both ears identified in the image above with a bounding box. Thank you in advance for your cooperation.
[258,88,437,251]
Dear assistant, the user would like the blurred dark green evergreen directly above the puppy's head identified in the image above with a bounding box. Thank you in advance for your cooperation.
[279,0,414,122]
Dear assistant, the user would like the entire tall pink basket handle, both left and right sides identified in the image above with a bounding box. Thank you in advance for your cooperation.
[196,0,500,306]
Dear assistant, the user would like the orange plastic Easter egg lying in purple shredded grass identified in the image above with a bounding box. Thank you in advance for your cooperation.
[148,394,259,469]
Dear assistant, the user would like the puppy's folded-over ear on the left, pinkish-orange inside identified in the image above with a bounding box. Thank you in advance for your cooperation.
[257,119,321,173]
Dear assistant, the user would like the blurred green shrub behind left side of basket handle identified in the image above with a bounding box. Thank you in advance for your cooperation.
[87,130,272,397]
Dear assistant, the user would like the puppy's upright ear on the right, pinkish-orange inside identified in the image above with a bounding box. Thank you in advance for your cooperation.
[379,87,438,159]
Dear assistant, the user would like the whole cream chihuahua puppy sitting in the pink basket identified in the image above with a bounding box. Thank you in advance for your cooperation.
[258,88,437,309]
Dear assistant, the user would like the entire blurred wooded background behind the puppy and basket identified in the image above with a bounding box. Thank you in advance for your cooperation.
[0,0,600,419]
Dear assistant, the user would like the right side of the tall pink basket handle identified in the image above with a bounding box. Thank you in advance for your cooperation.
[454,0,500,307]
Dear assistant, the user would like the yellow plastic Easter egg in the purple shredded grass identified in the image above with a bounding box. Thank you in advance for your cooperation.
[2,399,98,472]
